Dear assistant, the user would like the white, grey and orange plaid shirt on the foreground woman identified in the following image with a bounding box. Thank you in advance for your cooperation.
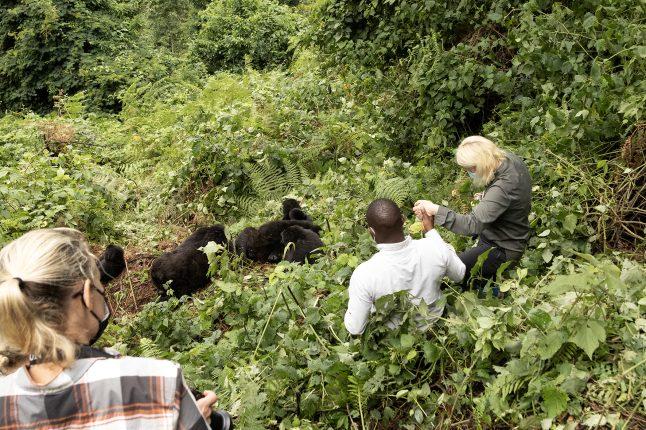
[0,357,210,430]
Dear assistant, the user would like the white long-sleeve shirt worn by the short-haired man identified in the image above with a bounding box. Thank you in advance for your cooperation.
[344,229,465,334]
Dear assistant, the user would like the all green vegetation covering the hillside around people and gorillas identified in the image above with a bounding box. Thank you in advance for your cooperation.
[0,0,646,429]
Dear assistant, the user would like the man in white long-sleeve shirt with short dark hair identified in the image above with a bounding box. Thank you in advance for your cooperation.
[344,199,465,334]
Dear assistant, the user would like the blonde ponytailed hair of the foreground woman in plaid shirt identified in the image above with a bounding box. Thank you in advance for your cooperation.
[0,228,100,367]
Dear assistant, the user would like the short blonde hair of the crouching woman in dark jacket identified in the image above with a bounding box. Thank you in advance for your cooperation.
[455,136,507,186]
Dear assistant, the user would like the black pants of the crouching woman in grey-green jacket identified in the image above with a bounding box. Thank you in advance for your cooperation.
[458,239,518,296]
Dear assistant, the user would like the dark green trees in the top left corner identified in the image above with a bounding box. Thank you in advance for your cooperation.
[0,0,137,111]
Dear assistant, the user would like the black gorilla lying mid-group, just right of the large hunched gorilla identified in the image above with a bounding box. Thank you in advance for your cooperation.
[233,220,321,263]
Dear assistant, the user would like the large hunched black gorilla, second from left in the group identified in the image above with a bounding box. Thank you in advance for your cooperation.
[150,224,227,297]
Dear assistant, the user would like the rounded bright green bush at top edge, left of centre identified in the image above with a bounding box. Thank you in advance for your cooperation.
[191,0,298,73]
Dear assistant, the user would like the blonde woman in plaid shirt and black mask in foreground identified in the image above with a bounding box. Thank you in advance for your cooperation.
[0,228,223,430]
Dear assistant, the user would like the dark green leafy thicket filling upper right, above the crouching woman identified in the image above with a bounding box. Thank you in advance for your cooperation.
[308,0,646,157]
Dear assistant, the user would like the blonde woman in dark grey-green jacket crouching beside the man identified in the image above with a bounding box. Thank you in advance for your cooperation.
[413,136,532,293]
